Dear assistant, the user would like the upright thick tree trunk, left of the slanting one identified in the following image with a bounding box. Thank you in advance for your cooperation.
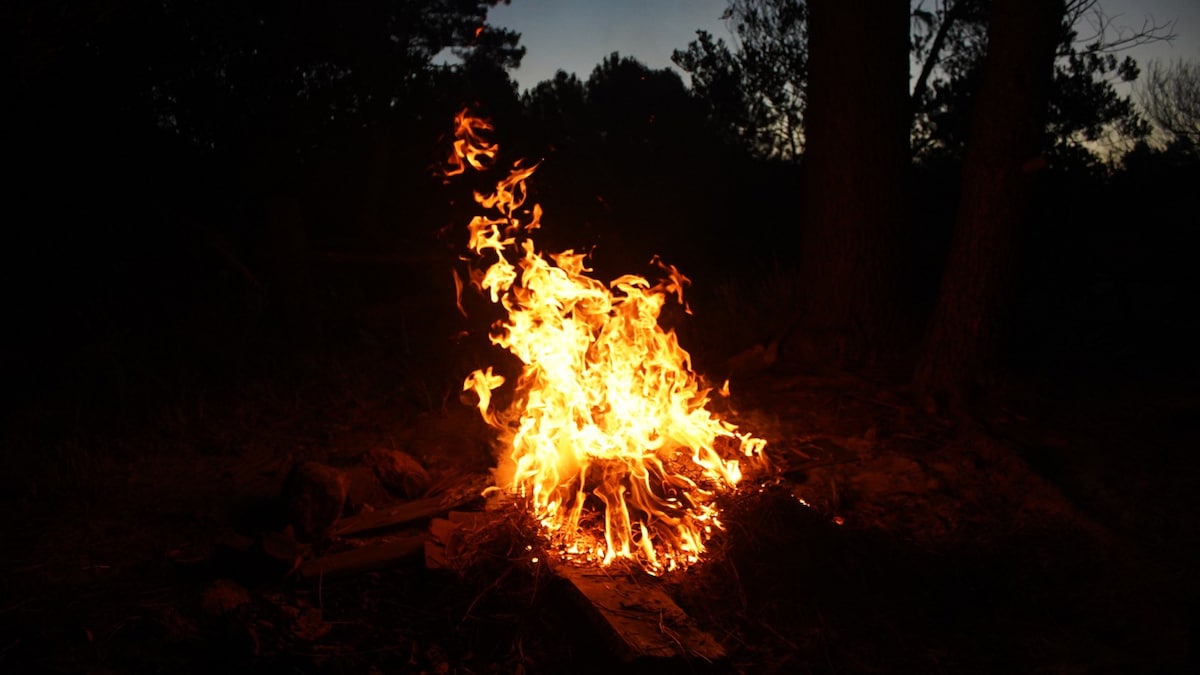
[782,0,910,368]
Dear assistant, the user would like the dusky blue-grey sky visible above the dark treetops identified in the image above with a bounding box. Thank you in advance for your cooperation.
[490,0,1200,90]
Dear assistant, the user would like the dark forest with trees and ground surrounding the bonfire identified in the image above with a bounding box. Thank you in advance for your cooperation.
[0,0,1200,673]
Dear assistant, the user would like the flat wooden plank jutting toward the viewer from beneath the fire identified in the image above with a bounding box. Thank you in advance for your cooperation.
[554,565,725,663]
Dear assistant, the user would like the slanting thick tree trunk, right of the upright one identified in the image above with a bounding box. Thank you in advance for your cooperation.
[914,0,1063,406]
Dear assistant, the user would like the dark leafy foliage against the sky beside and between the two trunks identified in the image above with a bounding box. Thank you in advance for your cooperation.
[672,0,1170,166]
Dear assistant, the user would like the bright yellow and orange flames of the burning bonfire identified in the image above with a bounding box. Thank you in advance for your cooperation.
[446,112,766,573]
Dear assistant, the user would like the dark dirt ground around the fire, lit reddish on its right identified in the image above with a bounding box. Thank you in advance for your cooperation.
[0,353,1200,674]
